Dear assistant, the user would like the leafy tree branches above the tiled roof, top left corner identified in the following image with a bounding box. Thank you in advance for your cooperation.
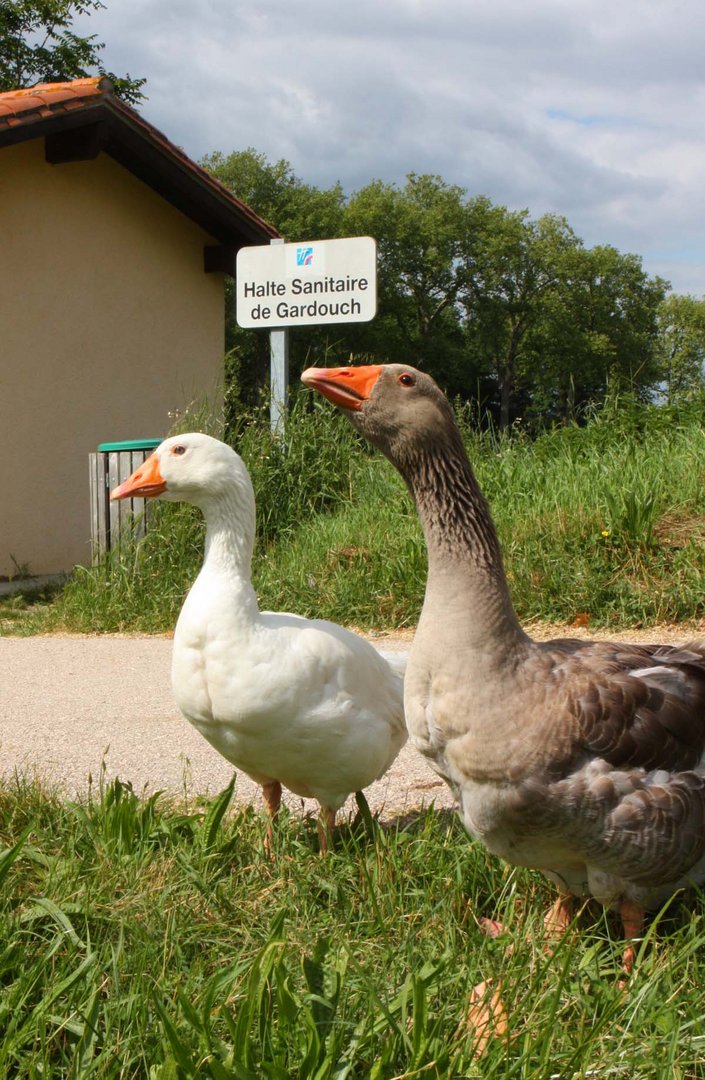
[0,0,145,104]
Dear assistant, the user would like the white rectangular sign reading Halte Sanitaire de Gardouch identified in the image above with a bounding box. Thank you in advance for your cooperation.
[235,237,377,329]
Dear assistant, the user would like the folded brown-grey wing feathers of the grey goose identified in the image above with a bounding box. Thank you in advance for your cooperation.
[515,639,705,887]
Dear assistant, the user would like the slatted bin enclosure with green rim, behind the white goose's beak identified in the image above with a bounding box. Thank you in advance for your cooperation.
[89,438,162,563]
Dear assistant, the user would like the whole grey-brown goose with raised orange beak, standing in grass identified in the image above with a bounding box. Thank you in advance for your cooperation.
[302,364,705,972]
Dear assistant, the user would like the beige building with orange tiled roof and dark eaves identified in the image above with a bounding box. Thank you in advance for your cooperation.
[0,78,277,578]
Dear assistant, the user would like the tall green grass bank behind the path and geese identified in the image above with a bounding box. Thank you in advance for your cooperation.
[5,395,705,632]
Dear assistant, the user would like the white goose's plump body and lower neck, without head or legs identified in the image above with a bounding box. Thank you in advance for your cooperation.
[172,566,404,810]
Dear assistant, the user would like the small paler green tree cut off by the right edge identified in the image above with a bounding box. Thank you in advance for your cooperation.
[656,294,705,405]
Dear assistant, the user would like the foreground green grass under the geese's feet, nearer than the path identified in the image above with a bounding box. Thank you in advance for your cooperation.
[0,780,705,1080]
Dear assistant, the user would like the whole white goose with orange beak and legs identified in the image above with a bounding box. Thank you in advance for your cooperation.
[110,433,407,850]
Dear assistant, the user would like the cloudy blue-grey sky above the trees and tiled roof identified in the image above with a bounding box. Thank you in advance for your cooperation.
[73,0,705,297]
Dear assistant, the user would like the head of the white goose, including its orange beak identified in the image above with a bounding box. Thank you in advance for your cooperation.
[110,432,254,510]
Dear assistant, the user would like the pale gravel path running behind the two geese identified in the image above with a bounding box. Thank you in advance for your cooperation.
[0,627,695,816]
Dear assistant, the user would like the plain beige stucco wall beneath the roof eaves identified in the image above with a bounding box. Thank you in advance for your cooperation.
[0,138,223,576]
